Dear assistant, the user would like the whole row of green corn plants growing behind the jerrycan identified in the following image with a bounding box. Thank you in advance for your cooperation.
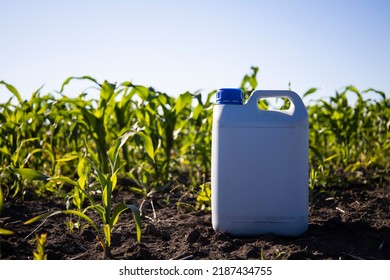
[0,67,390,258]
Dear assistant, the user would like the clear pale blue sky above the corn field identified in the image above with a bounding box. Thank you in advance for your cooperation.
[0,0,390,102]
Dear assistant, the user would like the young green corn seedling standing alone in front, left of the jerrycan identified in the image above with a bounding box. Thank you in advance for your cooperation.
[18,128,154,257]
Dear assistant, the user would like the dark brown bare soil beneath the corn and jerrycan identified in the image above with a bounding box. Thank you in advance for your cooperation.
[0,184,390,260]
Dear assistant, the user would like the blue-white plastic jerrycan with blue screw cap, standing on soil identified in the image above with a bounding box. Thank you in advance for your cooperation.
[211,89,309,236]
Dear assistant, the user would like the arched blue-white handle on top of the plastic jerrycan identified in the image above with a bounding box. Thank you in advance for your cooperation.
[246,90,307,115]
